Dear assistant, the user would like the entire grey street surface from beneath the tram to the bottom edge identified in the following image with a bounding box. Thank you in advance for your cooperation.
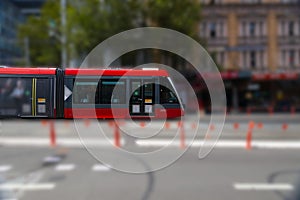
[0,116,300,200]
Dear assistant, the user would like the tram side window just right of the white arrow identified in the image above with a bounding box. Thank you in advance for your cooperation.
[73,80,99,104]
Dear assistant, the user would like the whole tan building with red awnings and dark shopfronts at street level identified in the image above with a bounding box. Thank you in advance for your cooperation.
[199,0,300,112]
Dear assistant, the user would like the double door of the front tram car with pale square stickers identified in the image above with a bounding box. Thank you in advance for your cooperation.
[129,79,155,116]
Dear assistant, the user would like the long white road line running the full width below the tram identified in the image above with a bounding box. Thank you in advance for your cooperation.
[0,138,300,149]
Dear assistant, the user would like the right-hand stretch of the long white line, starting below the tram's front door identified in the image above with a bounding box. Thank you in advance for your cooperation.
[135,139,300,149]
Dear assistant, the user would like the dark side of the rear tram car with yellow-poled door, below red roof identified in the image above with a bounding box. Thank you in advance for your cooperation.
[0,74,54,118]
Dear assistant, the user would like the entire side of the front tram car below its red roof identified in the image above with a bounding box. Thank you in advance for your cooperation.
[64,76,183,118]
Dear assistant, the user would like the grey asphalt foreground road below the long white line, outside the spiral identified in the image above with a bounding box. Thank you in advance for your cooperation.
[0,147,300,200]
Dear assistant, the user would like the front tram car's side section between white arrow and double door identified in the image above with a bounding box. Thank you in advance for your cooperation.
[64,76,128,118]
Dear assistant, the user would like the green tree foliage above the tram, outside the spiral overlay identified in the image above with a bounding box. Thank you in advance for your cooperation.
[19,0,200,66]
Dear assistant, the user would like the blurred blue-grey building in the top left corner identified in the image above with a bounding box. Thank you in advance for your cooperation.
[0,0,45,65]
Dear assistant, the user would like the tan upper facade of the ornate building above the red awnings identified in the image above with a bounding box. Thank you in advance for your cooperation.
[199,0,300,72]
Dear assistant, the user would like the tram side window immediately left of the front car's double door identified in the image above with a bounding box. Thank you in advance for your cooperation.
[100,79,126,104]
